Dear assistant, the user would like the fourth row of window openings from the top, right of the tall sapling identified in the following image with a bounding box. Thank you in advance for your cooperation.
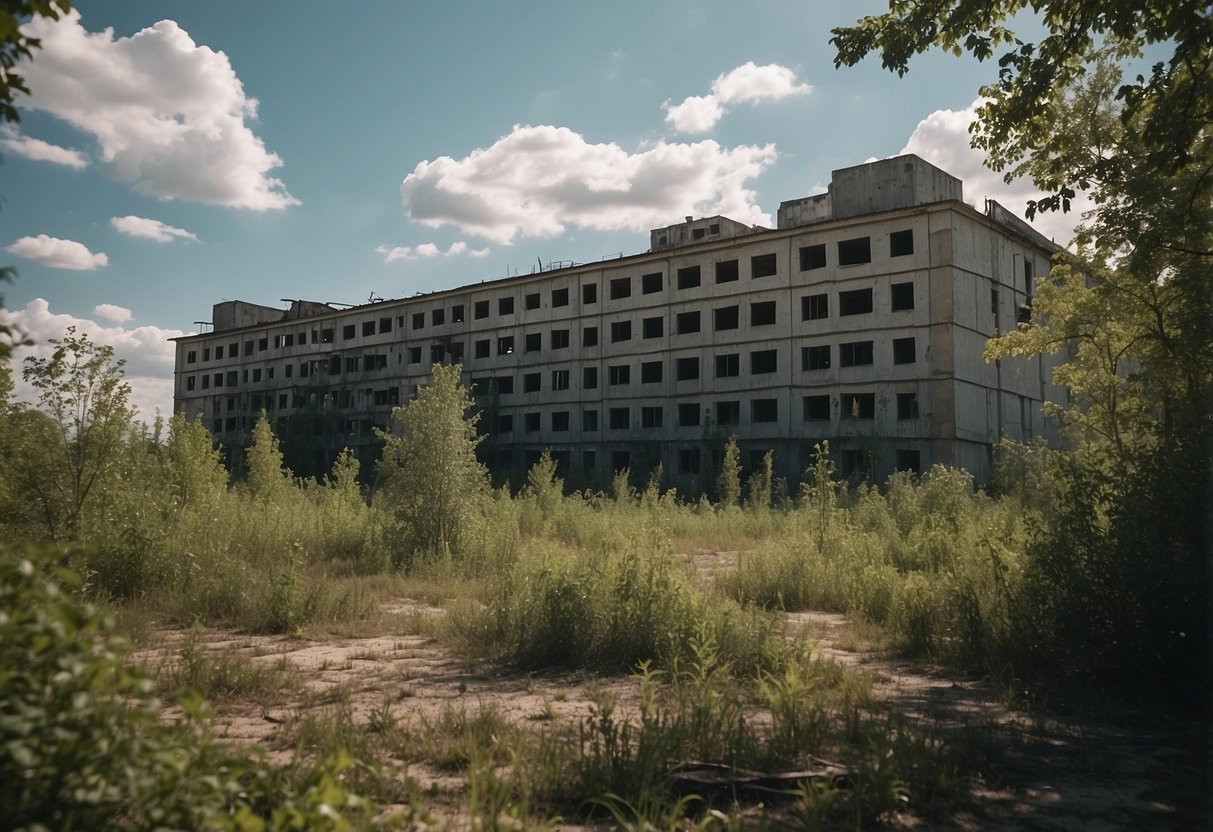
[482,393,918,434]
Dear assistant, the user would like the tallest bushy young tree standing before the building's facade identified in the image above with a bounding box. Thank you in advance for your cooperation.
[378,364,489,552]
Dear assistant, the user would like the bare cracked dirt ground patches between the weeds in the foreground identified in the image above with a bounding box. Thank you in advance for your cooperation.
[136,551,1213,832]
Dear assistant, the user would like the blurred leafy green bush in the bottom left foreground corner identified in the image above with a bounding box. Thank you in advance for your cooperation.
[0,548,374,830]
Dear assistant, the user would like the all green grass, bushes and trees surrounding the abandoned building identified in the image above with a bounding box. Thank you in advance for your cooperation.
[0,0,1213,830]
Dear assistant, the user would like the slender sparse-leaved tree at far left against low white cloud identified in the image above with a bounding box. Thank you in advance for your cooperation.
[22,326,133,540]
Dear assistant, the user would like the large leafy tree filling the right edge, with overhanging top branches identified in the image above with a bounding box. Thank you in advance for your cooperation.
[833,0,1213,706]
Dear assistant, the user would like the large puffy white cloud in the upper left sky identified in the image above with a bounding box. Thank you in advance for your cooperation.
[22,11,298,211]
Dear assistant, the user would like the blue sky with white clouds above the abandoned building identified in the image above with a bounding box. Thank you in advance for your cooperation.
[0,0,1081,417]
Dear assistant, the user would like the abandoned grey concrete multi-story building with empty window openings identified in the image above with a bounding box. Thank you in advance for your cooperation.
[175,155,1060,491]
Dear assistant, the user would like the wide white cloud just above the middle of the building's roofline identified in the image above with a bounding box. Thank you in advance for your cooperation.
[400,125,779,244]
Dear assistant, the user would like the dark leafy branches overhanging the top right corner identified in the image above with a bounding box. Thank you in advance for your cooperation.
[831,0,1213,214]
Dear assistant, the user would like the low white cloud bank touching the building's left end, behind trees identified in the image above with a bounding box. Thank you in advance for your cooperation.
[0,297,187,421]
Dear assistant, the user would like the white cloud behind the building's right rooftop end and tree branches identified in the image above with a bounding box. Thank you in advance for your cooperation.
[901,99,1092,245]
